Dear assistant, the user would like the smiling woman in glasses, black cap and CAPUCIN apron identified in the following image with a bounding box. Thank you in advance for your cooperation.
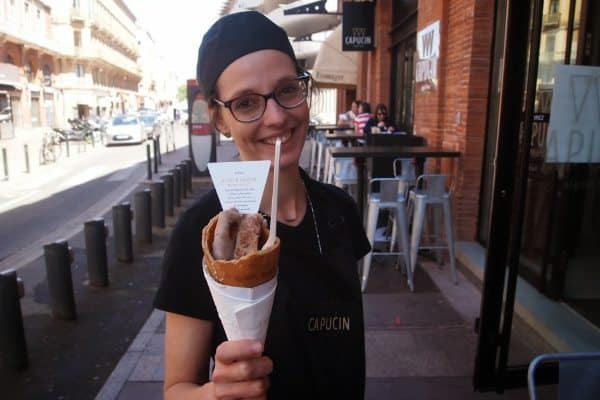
[155,12,370,400]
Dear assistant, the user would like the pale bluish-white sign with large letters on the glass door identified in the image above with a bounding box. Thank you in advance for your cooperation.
[546,64,600,163]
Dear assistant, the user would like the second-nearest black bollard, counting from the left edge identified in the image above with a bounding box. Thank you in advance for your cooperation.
[44,240,77,319]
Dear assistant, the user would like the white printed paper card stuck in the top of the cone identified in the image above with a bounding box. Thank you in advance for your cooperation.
[208,160,271,214]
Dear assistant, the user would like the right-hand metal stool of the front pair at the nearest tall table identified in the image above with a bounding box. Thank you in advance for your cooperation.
[408,175,458,283]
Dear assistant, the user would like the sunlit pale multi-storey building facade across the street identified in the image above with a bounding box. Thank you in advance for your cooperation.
[0,0,174,128]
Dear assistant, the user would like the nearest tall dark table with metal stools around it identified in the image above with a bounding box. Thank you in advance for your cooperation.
[329,146,460,218]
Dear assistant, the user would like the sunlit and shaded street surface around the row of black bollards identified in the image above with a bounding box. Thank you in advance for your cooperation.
[0,126,188,399]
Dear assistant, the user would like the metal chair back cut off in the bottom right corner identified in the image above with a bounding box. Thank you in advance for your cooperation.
[527,352,600,400]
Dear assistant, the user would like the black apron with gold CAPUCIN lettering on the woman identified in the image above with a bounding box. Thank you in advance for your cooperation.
[265,210,365,399]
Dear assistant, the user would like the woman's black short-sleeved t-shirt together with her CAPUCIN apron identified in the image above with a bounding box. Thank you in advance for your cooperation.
[154,171,370,399]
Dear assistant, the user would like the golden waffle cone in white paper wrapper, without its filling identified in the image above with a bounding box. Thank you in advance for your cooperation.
[202,216,280,343]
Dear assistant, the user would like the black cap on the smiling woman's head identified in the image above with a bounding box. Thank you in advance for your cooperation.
[196,11,297,95]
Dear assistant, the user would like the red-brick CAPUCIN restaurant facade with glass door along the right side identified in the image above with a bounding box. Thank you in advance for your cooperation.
[352,0,600,388]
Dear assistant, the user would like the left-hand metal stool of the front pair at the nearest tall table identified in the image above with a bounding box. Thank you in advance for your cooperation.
[361,178,414,291]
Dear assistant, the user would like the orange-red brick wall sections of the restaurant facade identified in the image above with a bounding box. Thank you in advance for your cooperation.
[357,0,494,240]
